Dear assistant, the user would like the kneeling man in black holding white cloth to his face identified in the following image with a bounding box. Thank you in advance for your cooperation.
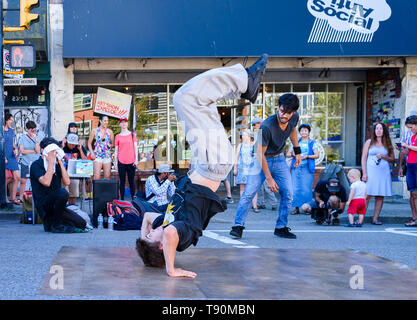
[30,138,70,232]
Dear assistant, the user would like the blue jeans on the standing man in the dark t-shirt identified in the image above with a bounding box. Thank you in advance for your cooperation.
[235,155,292,229]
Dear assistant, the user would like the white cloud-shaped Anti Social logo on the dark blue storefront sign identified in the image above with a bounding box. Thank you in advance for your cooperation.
[307,0,391,43]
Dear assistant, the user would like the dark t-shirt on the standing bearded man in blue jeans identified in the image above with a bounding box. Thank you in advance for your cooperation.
[257,112,299,156]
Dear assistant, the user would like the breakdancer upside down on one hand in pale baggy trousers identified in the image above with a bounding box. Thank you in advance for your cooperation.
[136,54,268,278]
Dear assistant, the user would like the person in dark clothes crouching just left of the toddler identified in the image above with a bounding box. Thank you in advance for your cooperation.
[301,178,347,226]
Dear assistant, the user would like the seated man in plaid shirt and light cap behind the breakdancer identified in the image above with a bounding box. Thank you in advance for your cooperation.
[145,164,177,211]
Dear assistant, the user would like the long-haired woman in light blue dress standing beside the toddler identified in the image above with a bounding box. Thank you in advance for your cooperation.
[361,123,395,225]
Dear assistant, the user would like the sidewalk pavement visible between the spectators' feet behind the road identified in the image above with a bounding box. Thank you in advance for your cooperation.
[0,185,412,225]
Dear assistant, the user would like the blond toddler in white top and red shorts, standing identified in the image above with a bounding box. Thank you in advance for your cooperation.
[345,169,366,227]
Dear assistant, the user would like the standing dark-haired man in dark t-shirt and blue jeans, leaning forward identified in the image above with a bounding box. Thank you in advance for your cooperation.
[230,93,301,239]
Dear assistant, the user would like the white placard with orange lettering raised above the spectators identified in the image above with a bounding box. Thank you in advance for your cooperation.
[94,87,132,119]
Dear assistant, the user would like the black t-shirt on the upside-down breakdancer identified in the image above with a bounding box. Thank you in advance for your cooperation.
[152,176,225,251]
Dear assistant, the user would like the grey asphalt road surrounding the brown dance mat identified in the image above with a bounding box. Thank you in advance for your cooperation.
[0,202,417,300]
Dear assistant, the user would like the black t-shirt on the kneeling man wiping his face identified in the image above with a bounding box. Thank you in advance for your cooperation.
[30,157,62,207]
